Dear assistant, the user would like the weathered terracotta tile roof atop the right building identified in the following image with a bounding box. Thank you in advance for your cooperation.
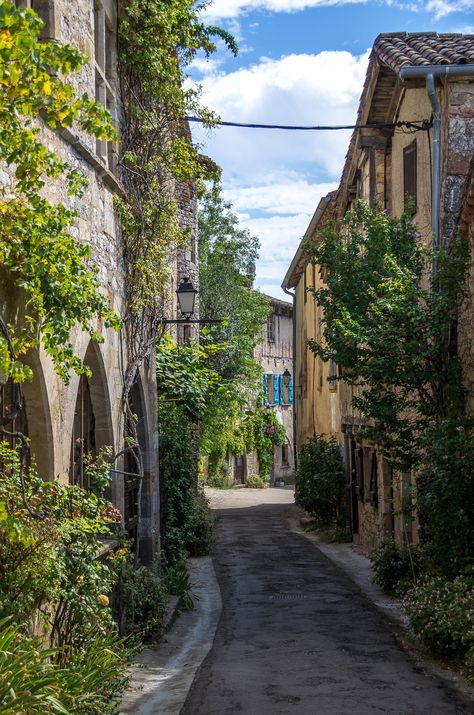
[374,32,474,73]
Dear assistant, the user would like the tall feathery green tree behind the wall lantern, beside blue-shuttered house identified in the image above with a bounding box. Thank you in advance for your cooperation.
[199,187,273,477]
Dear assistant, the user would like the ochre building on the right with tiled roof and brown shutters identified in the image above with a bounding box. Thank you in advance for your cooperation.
[283,33,474,548]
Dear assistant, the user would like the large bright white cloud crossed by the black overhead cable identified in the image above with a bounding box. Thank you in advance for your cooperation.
[196,52,368,180]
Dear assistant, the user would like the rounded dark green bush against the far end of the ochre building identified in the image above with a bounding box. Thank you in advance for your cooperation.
[295,435,345,526]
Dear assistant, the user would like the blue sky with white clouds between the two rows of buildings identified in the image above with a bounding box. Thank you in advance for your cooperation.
[191,0,474,298]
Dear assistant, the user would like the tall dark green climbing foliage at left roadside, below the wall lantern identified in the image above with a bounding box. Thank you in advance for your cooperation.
[159,404,212,565]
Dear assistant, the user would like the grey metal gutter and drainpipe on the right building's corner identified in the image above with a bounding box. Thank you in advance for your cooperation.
[400,64,474,278]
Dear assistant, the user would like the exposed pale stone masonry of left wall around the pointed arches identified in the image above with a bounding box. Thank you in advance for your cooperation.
[0,0,167,560]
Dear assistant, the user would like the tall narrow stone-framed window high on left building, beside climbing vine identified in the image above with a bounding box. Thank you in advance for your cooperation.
[94,2,117,171]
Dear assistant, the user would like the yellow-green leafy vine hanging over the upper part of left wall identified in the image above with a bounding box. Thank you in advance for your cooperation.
[0,0,120,382]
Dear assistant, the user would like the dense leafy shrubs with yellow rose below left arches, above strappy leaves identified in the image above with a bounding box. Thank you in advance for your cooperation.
[0,442,120,653]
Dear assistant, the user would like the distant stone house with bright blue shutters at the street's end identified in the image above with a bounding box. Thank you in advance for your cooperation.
[254,296,295,484]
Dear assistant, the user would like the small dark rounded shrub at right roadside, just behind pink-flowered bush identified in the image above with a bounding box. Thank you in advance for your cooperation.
[370,538,420,594]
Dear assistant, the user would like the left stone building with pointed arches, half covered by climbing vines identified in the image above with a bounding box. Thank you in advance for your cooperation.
[0,0,197,561]
